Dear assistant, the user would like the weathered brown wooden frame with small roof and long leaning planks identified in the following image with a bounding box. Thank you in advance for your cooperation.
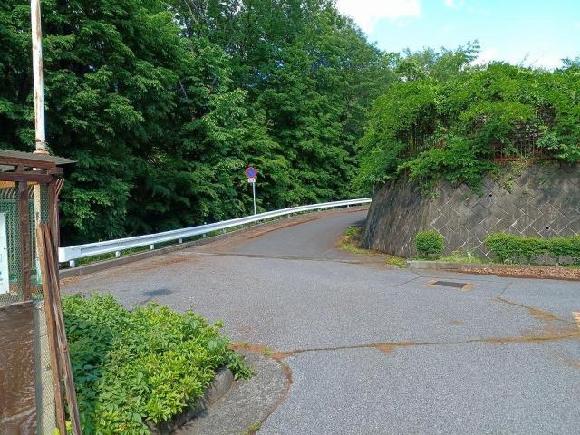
[0,150,81,435]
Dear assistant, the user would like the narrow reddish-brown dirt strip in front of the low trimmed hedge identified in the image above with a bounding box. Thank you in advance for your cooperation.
[454,264,580,281]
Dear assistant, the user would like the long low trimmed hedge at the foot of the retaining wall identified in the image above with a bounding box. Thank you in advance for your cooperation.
[485,233,580,264]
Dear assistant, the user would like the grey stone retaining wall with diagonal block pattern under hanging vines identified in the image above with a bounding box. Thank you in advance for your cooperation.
[363,163,580,257]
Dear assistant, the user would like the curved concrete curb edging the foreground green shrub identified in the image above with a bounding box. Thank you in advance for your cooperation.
[148,369,234,435]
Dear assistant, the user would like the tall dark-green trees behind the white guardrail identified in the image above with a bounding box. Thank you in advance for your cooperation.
[0,0,393,243]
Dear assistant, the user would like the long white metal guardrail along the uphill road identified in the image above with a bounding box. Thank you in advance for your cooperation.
[58,198,372,267]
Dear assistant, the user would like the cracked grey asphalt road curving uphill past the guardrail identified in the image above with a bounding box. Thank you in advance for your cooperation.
[65,210,580,434]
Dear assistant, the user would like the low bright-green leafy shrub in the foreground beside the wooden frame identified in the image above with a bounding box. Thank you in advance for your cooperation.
[63,295,250,434]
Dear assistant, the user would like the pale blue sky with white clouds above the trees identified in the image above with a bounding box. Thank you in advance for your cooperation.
[336,0,580,69]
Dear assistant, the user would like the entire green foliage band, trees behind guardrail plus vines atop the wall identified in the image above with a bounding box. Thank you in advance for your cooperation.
[0,0,580,244]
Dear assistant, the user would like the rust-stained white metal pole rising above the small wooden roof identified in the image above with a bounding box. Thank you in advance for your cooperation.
[30,0,48,154]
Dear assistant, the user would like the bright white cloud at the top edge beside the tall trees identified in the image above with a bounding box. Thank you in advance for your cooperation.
[336,0,421,33]
